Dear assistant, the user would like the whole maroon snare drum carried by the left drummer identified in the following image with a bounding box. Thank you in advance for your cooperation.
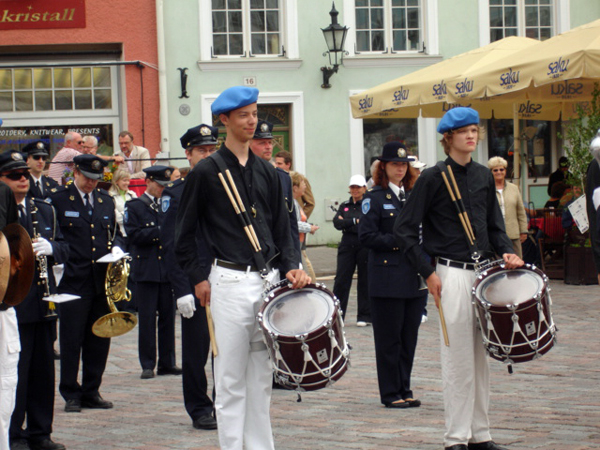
[258,280,350,391]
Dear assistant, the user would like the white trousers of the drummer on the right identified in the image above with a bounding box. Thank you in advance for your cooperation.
[436,264,492,447]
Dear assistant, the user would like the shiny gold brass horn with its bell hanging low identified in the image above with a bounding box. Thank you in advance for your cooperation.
[92,256,137,338]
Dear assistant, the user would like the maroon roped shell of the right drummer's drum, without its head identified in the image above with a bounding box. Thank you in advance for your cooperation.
[473,265,556,363]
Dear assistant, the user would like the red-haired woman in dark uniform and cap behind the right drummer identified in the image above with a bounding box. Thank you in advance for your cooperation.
[358,142,427,408]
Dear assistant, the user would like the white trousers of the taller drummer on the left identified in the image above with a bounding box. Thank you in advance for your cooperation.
[209,265,279,450]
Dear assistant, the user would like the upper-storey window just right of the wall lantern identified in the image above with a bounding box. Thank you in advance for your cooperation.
[354,0,423,53]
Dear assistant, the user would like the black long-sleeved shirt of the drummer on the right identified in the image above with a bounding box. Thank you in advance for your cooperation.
[394,157,514,278]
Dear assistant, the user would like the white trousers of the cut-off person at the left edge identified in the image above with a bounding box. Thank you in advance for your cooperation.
[0,308,21,450]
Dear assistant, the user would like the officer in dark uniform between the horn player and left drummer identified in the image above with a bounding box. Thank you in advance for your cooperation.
[123,166,181,379]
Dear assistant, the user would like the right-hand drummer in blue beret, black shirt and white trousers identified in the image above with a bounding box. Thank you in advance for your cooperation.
[394,107,523,450]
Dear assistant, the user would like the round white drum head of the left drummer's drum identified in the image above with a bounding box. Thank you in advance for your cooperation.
[264,288,335,336]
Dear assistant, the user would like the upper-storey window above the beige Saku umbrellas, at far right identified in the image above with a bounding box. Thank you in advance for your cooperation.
[489,0,554,42]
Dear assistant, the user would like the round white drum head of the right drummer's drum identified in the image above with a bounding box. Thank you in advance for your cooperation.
[477,269,544,306]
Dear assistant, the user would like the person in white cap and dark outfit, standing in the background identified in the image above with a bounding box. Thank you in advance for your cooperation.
[333,175,371,327]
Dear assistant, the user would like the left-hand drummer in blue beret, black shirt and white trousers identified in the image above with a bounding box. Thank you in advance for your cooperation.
[175,86,310,450]
